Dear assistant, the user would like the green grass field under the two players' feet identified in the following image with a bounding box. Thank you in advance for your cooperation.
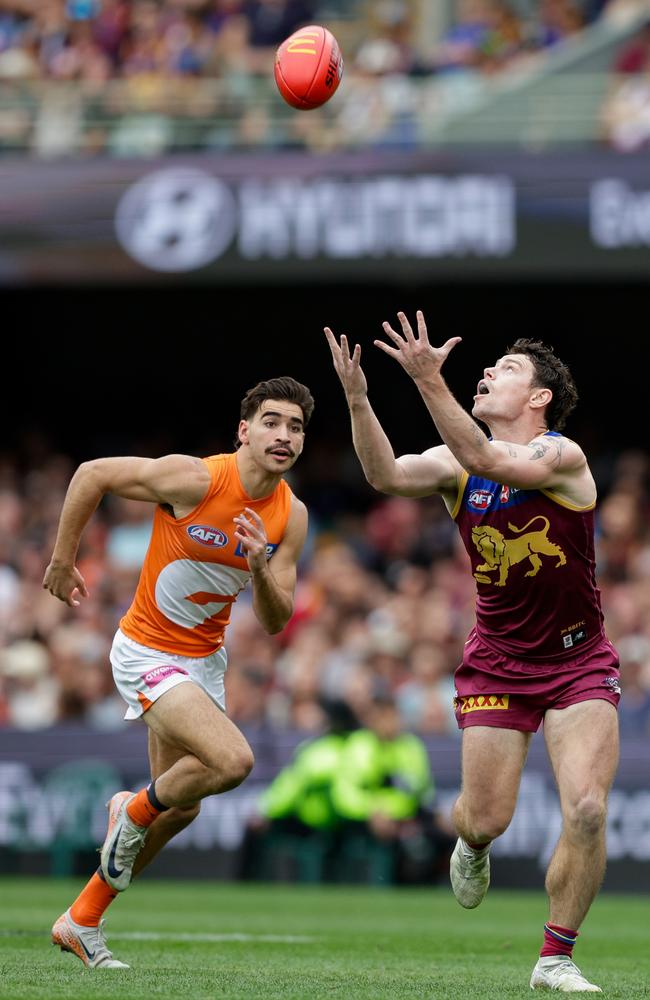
[0,879,650,1000]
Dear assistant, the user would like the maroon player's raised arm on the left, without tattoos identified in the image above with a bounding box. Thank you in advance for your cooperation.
[325,327,460,497]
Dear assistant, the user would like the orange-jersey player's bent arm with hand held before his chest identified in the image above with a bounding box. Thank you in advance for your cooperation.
[235,497,307,635]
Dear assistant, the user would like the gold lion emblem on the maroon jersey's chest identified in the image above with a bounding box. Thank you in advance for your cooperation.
[472,514,566,587]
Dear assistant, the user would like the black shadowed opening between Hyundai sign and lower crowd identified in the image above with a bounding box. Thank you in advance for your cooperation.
[8,283,636,458]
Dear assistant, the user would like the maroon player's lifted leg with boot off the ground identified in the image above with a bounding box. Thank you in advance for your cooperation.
[449,726,531,909]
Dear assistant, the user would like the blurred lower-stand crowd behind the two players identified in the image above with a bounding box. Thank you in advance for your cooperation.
[0,449,650,736]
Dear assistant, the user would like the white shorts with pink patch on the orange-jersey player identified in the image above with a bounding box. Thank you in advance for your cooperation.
[111,629,228,719]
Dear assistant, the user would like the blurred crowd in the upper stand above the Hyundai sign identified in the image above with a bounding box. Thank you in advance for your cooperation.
[0,0,632,156]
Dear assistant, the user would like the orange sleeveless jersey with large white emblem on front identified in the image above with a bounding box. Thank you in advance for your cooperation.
[120,453,291,656]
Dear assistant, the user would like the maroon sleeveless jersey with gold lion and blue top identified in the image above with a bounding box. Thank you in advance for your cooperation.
[453,452,604,662]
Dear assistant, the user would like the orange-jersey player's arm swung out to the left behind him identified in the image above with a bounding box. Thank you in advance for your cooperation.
[43,455,210,607]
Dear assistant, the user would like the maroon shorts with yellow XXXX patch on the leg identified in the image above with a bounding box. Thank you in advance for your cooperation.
[454,629,621,733]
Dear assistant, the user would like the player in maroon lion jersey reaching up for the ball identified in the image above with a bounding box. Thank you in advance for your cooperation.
[325,312,620,993]
